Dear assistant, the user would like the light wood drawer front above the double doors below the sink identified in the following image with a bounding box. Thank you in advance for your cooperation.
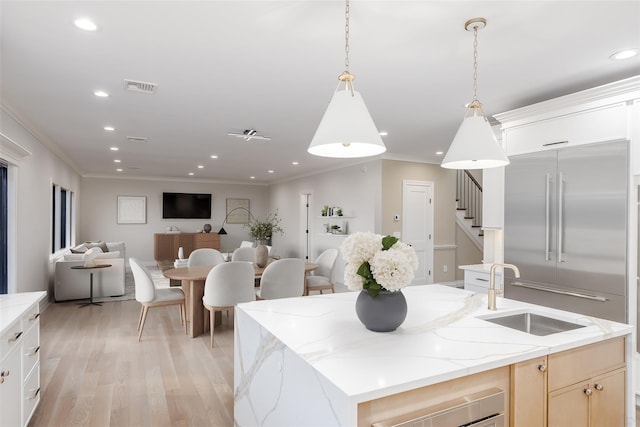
[548,337,625,391]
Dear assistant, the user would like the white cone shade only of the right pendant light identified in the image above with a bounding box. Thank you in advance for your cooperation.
[441,115,509,169]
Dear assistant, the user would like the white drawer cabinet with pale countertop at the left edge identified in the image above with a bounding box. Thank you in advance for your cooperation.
[0,292,46,426]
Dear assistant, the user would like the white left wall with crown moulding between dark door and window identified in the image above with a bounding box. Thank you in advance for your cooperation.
[0,109,80,294]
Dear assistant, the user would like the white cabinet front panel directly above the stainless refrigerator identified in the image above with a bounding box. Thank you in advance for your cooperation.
[503,103,627,156]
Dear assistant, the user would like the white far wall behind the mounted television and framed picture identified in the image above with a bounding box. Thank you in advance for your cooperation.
[78,177,269,261]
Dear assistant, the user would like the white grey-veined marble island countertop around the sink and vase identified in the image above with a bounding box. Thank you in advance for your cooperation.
[238,285,633,402]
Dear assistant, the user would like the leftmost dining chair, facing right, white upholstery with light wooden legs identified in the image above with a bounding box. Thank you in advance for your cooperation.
[129,258,187,341]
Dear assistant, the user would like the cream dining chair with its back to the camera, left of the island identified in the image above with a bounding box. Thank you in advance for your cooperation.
[202,261,256,347]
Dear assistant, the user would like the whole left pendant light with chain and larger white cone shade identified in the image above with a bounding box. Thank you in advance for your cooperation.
[307,0,387,158]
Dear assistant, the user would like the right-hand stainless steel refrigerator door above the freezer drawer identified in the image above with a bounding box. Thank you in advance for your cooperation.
[556,141,628,300]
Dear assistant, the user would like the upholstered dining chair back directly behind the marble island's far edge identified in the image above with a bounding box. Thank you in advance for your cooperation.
[256,258,304,299]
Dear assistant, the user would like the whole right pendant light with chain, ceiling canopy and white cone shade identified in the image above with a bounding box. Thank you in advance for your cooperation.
[441,18,509,169]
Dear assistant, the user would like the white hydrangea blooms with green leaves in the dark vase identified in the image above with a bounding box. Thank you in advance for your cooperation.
[340,232,418,297]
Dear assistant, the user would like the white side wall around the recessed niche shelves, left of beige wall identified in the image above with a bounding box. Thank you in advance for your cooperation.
[269,160,382,283]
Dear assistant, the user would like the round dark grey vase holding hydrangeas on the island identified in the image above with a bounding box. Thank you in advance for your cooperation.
[356,290,407,332]
